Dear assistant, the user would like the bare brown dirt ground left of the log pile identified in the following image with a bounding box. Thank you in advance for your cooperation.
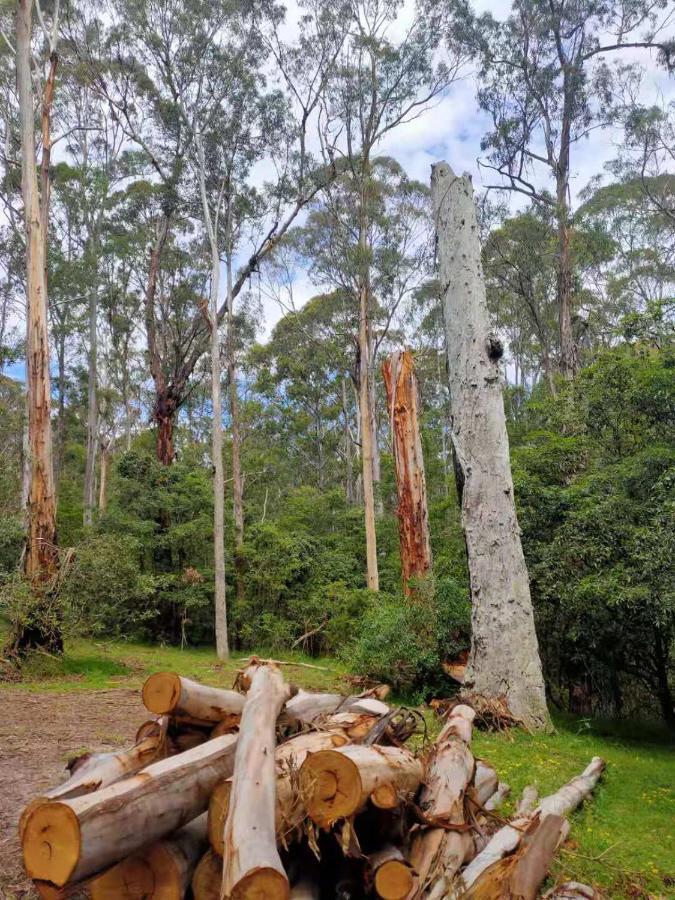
[0,690,148,900]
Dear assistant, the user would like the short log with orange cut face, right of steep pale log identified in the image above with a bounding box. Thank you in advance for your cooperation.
[300,744,422,828]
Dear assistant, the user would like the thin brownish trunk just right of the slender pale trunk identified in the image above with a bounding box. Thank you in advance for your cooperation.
[227,250,246,601]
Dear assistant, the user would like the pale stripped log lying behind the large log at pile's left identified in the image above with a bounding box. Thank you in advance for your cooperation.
[19,718,169,839]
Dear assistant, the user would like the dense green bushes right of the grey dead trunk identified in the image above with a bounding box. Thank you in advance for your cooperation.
[513,348,675,723]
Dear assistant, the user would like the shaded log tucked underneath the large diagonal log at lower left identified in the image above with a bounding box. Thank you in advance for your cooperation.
[89,814,206,900]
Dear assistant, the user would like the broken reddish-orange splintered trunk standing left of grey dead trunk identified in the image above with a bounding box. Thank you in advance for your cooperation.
[382,350,431,595]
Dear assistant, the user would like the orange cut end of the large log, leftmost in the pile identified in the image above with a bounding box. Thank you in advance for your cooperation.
[22,802,81,887]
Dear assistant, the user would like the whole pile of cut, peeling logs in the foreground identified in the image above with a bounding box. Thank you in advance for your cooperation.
[20,659,604,900]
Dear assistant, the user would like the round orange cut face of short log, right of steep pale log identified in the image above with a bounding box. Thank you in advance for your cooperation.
[300,750,361,826]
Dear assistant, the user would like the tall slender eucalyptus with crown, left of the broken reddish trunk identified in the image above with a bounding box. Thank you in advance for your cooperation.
[322,0,458,590]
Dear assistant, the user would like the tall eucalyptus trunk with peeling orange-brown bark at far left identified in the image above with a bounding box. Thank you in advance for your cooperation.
[16,0,62,650]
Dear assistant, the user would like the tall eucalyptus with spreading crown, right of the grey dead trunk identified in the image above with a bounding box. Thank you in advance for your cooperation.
[444,0,675,378]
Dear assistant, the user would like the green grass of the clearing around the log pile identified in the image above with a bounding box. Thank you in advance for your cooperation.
[0,640,675,900]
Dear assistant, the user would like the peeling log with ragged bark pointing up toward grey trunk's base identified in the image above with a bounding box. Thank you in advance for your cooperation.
[410,705,475,896]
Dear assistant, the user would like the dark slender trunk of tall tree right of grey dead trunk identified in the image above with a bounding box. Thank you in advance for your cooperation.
[556,94,577,379]
